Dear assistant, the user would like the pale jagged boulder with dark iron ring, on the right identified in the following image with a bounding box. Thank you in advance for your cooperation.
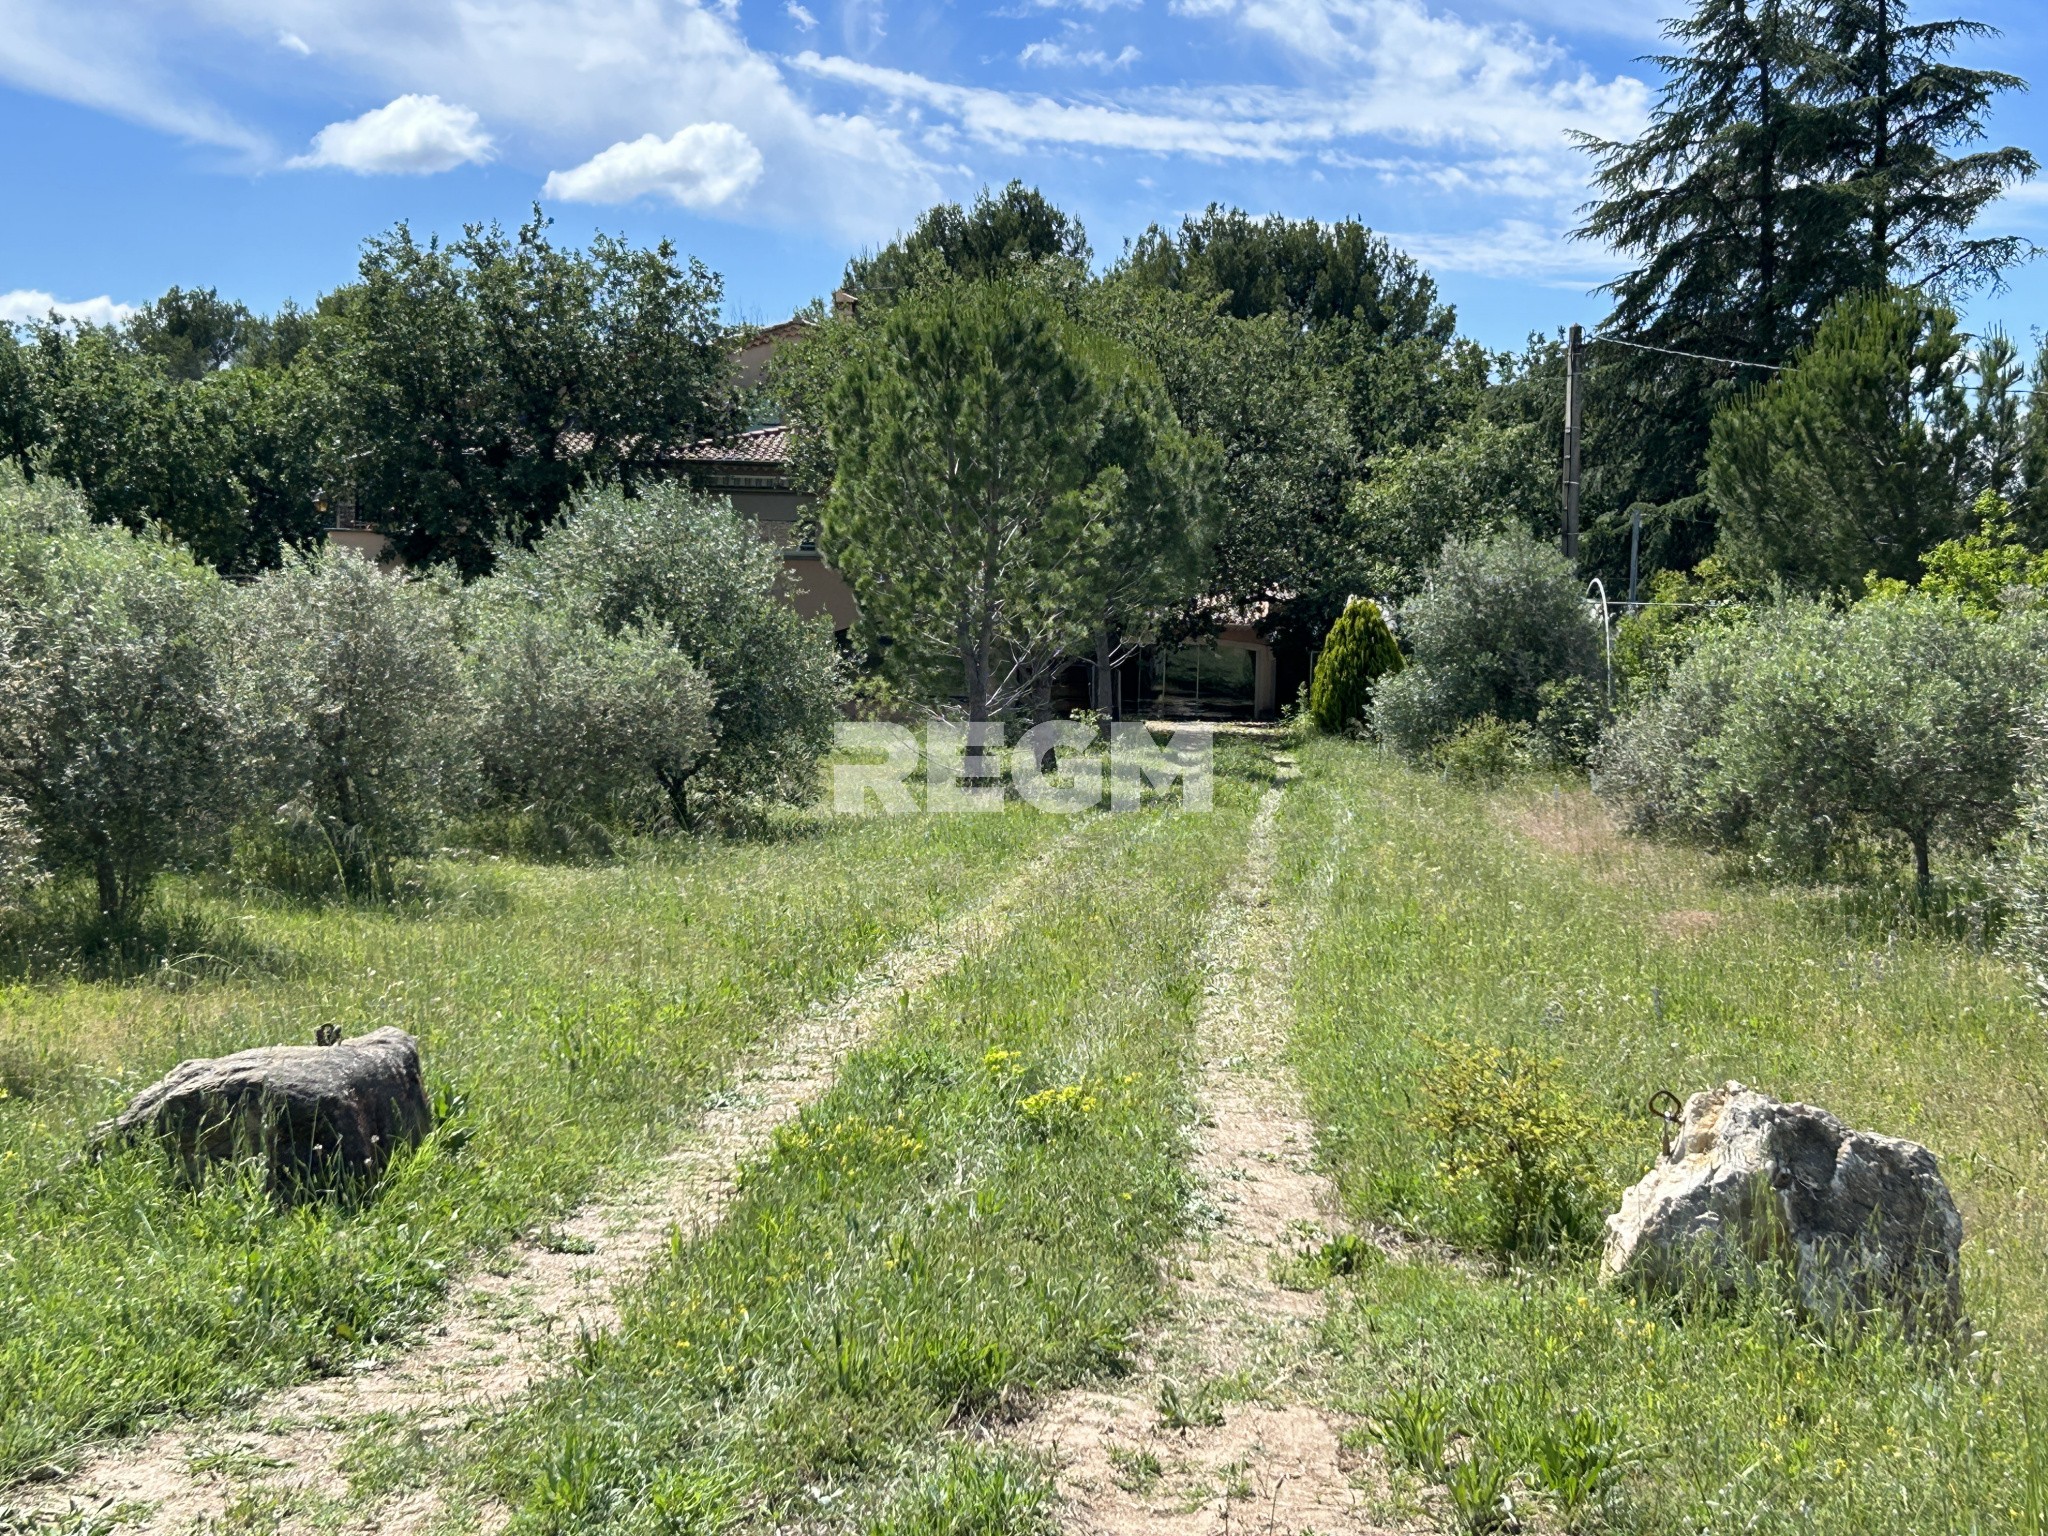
[1602,1083,1962,1329]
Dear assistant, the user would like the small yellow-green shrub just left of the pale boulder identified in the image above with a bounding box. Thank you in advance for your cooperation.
[1419,1040,1604,1257]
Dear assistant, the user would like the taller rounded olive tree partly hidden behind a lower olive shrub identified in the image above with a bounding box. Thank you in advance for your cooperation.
[522,485,842,825]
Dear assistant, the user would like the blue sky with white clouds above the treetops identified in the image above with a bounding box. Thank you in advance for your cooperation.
[0,0,2048,346]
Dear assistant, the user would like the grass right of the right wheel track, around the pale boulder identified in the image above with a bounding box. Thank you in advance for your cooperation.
[1282,741,2048,1536]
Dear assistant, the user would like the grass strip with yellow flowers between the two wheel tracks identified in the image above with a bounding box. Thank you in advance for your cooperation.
[456,748,1268,1536]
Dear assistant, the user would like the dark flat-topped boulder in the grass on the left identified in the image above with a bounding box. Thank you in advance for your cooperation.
[92,1028,434,1198]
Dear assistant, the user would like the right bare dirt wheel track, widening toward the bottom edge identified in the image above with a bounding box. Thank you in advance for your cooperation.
[1020,756,1400,1536]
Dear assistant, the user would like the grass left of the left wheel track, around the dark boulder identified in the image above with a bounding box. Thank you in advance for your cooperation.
[0,811,1071,1483]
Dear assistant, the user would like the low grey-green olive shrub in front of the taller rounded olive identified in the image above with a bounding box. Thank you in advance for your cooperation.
[469,606,711,844]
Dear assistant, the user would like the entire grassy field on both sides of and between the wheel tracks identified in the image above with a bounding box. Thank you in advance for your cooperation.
[0,739,2048,1536]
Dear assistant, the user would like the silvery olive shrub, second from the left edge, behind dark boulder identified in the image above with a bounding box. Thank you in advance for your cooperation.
[233,549,469,893]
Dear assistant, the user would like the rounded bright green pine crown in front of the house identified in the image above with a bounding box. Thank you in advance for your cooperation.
[819,283,1200,719]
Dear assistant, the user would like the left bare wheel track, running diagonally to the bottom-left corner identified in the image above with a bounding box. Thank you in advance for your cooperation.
[16,831,1098,1536]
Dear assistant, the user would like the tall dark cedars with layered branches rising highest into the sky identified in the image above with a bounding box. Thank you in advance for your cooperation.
[1577,0,2034,565]
